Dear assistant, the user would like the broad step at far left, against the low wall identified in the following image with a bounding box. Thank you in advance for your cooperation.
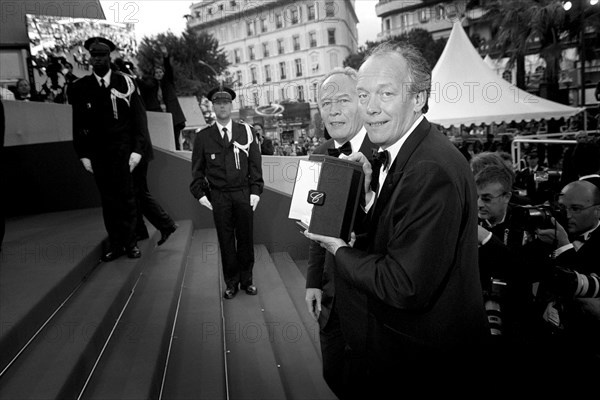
[0,208,106,375]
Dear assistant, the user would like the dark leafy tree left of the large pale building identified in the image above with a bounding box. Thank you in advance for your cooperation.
[137,28,229,96]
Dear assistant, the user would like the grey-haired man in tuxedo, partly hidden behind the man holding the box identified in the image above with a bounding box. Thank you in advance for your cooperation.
[306,67,376,399]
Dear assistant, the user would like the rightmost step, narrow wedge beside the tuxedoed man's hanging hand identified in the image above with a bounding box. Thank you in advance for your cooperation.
[271,252,321,358]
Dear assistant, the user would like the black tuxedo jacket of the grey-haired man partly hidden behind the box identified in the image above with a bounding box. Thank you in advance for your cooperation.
[306,131,378,327]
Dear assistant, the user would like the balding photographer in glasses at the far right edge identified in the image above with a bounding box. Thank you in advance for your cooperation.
[537,180,600,378]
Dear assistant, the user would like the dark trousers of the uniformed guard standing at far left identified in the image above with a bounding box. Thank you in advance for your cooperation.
[92,153,137,249]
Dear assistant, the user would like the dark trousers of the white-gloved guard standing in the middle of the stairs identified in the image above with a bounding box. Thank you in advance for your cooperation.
[211,188,254,286]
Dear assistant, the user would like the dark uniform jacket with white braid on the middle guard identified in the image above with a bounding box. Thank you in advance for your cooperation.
[190,122,264,199]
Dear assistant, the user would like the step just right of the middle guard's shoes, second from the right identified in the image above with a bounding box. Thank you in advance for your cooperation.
[255,246,336,399]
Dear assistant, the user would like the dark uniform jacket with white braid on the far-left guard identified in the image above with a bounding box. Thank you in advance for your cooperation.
[68,71,147,159]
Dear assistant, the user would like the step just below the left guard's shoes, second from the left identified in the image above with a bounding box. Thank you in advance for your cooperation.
[0,228,158,400]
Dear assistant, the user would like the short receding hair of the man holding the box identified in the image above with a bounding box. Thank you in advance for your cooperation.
[366,41,431,114]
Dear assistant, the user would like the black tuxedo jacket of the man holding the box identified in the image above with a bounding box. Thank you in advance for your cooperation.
[335,119,489,358]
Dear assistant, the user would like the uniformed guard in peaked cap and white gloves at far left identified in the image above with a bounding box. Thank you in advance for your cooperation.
[68,37,148,262]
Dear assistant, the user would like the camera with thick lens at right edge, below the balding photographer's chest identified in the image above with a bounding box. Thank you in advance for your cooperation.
[549,267,600,298]
